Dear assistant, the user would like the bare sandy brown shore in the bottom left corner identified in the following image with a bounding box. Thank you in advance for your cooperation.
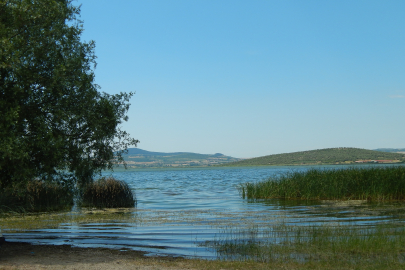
[0,242,195,270]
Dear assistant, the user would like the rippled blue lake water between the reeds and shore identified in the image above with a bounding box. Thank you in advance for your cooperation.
[4,166,403,259]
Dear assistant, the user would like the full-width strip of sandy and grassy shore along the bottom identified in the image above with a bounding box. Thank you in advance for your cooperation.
[0,242,404,270]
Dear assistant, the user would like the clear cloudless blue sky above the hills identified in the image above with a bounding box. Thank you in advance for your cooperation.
[74,0,405,158]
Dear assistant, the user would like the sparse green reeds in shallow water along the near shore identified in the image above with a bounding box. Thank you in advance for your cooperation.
[204,224,405,265]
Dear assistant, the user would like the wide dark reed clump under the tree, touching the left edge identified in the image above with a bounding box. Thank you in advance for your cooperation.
[0,180,73,212]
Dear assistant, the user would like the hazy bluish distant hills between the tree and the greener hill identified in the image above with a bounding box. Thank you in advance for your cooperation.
[118,148,241,168]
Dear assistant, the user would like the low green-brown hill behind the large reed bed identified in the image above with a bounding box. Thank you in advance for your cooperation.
[226,147,405,166]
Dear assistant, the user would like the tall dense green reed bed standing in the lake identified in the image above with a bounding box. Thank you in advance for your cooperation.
[240,166,405,201]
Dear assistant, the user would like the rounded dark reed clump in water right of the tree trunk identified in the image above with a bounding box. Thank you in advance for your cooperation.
[80,177,136,208]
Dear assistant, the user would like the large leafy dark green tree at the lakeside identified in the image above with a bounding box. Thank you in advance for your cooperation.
[0,0,138,187]
